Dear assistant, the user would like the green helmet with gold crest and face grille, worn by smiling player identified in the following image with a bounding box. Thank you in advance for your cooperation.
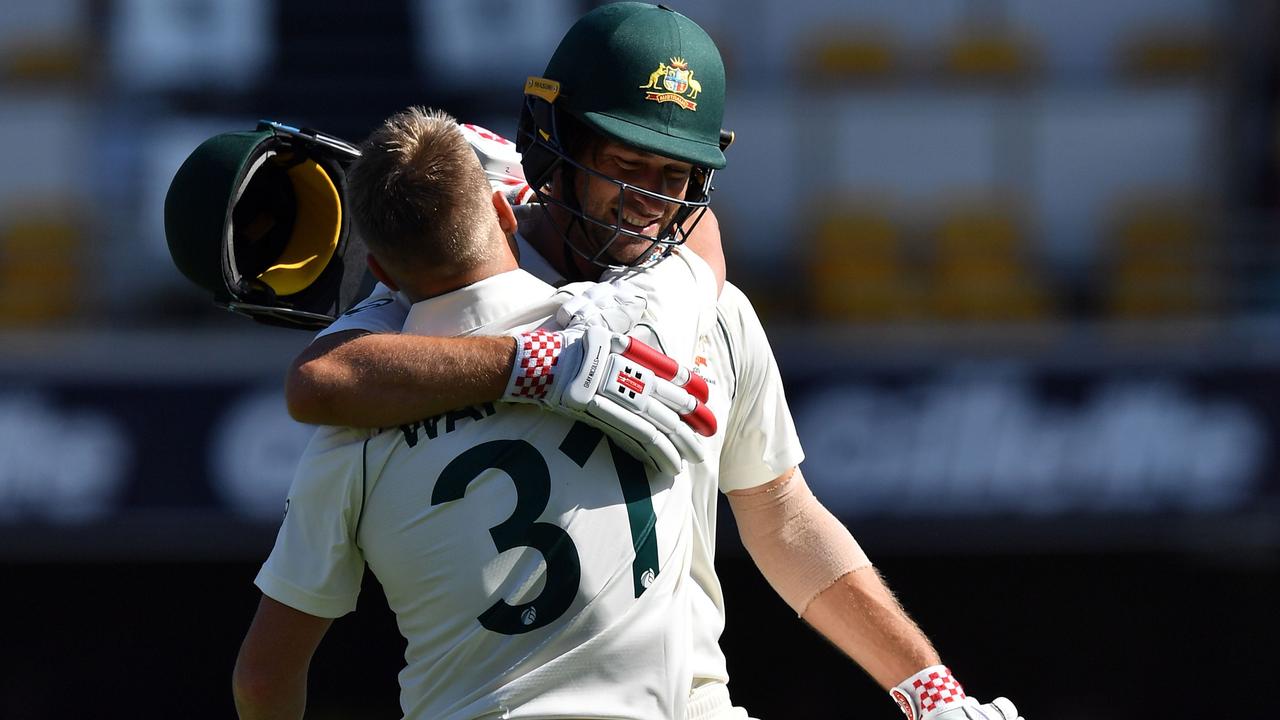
[517,3,731,271]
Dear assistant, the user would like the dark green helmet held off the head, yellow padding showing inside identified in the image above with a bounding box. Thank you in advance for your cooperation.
[164,120,370,329]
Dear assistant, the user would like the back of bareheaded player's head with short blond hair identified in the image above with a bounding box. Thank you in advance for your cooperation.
[348,106,497,277]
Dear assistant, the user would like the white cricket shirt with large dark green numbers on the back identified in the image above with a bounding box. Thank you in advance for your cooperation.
[257,258,714,719]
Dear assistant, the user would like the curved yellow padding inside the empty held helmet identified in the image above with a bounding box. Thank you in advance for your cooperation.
[257,160,342,295]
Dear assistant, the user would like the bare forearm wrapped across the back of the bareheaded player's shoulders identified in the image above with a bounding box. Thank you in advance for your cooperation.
[285,333,515,428]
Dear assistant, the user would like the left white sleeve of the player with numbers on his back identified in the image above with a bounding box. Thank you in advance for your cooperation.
[253,428,367,618]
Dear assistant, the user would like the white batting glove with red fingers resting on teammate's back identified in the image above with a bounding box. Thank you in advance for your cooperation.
[503,325,716,474]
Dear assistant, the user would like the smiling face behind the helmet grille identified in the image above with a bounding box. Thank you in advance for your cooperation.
[575,138,692,265]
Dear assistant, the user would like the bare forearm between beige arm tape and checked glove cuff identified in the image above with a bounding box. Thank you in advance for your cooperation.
[804,568,941,689]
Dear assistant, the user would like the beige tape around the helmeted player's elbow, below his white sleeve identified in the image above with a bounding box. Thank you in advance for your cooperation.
[727,470,872,616]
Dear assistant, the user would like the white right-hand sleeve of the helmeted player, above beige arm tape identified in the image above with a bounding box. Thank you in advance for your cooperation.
[719,283,804,492]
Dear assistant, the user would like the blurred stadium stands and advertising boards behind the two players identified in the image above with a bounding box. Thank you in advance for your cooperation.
[0,0,1280,720]
